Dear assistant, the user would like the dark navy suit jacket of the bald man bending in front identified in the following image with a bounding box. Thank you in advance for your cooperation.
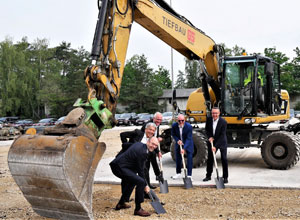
[110,142,148,180]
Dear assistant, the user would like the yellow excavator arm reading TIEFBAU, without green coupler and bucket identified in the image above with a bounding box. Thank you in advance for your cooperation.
[85,0,222,117]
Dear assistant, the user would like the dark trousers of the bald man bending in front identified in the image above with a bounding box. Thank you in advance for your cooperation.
[110,163,145,204]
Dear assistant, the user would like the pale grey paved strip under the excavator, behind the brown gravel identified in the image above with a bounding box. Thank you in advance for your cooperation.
[94,148,300,189]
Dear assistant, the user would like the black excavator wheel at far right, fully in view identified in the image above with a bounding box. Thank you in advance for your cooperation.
[261,131,300,170]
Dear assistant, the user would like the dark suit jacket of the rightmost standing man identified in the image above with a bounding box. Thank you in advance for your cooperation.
[205,117,227,149]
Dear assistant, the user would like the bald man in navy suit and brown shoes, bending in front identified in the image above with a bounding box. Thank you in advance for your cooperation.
[109,137,158,216]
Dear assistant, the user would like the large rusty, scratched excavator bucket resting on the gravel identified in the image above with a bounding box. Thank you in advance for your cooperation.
[8,134,105,219]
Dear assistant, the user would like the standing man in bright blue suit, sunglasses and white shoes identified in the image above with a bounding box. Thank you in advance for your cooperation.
[171,114,194,179]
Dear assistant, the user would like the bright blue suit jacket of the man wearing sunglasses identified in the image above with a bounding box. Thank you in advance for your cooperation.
[171,122,194,153]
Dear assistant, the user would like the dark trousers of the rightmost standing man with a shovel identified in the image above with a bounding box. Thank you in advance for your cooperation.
[206,143,228,179]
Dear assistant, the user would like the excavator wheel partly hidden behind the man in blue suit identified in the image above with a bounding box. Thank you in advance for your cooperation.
[171,132,208,168]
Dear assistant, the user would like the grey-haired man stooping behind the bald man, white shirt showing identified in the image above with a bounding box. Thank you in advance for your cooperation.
[120,122,160,189]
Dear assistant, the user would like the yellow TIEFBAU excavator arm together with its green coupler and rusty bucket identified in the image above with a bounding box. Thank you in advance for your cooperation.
[8,0,222,219]
